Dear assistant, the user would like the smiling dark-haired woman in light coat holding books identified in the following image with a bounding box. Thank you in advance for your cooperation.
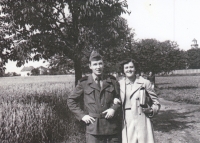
[114,59,160,143]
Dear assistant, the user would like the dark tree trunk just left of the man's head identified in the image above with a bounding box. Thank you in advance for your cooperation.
[74,59,82,86]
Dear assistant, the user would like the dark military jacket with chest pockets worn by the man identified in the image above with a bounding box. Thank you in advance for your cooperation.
[68,75,120,135]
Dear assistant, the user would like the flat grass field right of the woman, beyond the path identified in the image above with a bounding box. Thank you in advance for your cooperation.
[156,76,200,104]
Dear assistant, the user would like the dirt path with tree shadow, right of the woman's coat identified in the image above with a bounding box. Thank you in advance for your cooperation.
[153,98,200,143]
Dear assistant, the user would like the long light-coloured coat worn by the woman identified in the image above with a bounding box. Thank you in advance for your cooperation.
[119,77,160,143]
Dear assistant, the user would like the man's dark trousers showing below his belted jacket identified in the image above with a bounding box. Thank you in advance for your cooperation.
[86,133,121,143]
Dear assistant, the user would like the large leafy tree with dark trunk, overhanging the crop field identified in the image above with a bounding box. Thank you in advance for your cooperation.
[0,0,127,83]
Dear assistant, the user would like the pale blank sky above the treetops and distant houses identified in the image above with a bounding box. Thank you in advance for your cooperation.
[6,0,200,73]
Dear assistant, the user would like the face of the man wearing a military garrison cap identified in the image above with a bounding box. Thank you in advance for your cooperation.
[89,60,104,76]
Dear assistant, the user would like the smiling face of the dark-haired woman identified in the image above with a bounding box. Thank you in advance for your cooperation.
[124,62,135,77]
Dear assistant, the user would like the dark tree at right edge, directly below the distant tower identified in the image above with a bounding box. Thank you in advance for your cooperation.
[187,48,200,69]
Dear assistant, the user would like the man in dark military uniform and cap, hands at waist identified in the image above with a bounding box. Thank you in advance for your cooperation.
[68,51,121,143]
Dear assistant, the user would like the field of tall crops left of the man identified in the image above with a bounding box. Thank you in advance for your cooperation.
[0,76,82,143]
